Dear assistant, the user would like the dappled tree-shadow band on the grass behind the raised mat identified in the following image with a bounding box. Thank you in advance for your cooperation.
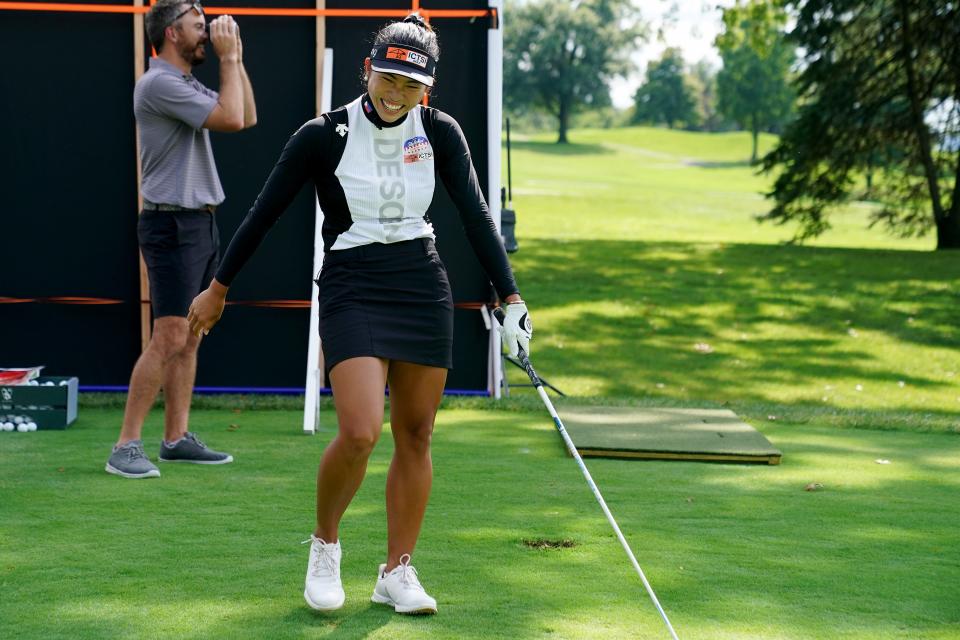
[511,239,960,402]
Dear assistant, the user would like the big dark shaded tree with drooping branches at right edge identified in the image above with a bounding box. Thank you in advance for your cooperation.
[764,0,960,249]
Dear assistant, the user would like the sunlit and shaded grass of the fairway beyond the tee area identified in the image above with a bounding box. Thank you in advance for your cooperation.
[511,128,960,424]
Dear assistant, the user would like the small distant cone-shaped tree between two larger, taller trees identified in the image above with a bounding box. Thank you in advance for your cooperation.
[633,47,697,129]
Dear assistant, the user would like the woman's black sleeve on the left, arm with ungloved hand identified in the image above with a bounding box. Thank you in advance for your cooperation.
[216,117,332,286]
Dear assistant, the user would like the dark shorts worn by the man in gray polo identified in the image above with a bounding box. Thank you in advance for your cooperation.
[137,211,220,318]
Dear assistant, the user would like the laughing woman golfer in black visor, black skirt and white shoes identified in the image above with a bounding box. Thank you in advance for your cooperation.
[188,15,532,613]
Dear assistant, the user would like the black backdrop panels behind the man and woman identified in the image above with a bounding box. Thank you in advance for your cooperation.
[0,0,491,390]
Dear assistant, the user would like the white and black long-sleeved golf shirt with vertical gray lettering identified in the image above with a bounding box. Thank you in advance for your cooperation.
[216,95,518,298]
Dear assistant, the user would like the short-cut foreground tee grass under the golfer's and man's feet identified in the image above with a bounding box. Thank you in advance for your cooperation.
[0,408,960,640]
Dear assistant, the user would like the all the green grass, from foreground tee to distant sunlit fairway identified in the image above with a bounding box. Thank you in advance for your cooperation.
[0,128,960,640]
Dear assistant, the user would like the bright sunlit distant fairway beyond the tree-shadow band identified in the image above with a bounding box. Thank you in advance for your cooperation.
[504,127,935,250]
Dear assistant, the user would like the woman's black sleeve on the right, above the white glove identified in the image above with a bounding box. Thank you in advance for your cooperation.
[430,110,520,299]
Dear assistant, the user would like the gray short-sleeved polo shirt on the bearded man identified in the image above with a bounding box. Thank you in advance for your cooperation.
[133,58,224,209]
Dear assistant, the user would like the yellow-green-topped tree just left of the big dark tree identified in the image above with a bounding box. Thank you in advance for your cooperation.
[716,0,795,163]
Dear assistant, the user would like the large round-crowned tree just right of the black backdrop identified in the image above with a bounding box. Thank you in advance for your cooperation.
[503,0,642,143]
